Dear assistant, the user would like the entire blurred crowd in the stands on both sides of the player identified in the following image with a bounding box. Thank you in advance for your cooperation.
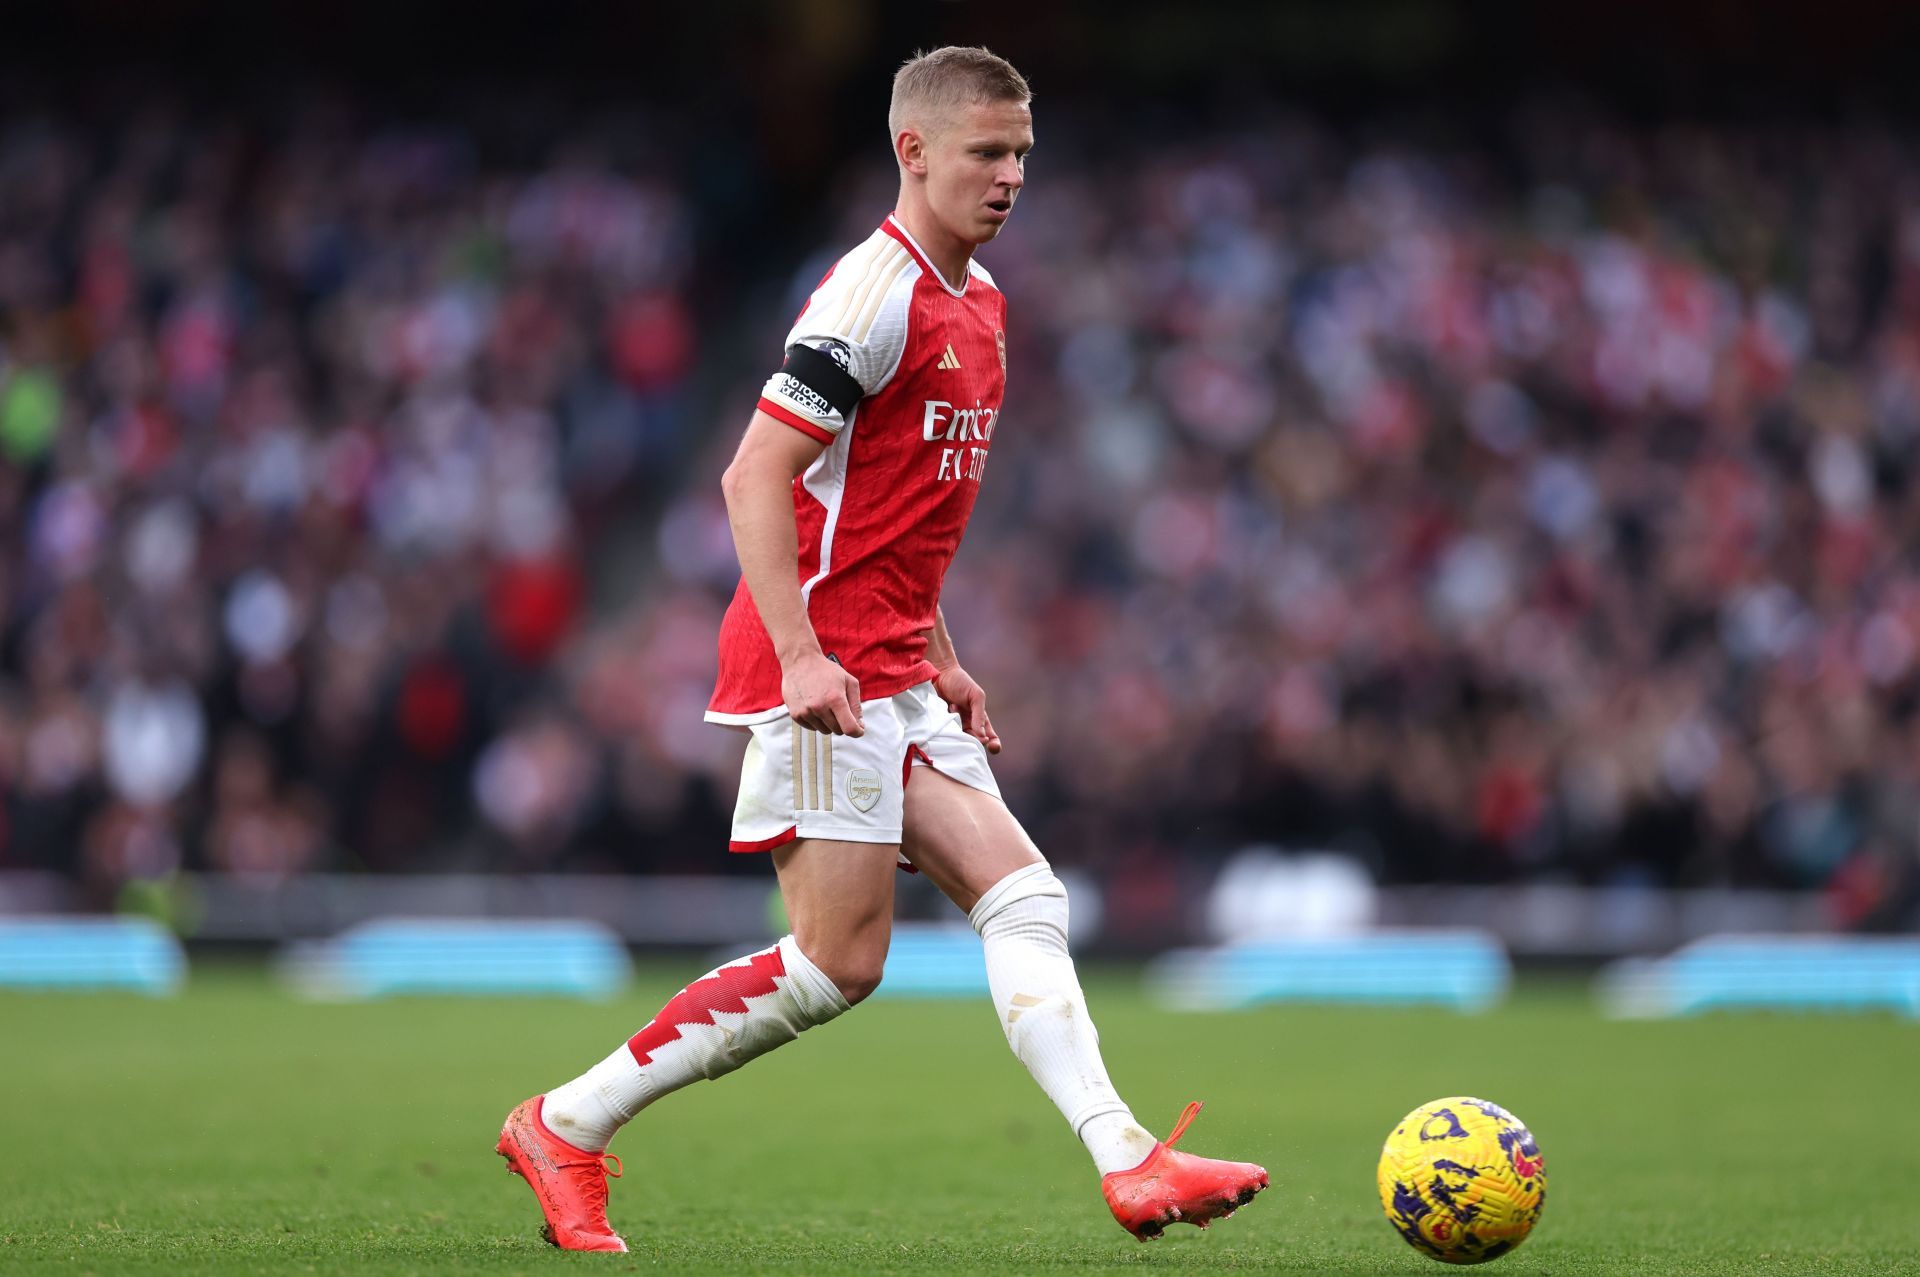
[11,104,1920,926]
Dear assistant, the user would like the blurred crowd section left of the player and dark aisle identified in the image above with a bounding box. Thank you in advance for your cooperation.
[0,108,714,895]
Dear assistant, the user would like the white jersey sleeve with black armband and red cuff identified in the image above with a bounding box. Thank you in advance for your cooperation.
[760,234,918,444]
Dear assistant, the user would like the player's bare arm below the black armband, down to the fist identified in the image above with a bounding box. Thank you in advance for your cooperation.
[720,409,864,735]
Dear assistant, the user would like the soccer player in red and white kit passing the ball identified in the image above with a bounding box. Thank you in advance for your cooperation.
[497,48,1267,1250]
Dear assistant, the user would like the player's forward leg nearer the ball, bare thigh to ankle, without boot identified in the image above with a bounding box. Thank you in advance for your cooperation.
[904,766,1158,1175]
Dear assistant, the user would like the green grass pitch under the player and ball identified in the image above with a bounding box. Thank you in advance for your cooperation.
[0,960,1920,1277]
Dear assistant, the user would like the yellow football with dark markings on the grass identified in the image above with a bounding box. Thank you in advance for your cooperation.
[1380,1095,1548,1264]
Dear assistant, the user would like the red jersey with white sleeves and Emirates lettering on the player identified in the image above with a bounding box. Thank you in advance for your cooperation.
[707,217,1006,724]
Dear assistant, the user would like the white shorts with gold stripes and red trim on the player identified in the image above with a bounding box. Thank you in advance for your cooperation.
[728,682,1000,851]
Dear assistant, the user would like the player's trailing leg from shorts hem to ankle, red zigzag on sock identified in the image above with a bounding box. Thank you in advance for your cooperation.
[541,837,897,1152]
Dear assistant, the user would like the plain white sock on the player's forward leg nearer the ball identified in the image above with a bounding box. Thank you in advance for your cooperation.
[968,862,1156,1175]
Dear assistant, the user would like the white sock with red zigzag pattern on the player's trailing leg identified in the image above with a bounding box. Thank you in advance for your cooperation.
[541,935,847,1152]
